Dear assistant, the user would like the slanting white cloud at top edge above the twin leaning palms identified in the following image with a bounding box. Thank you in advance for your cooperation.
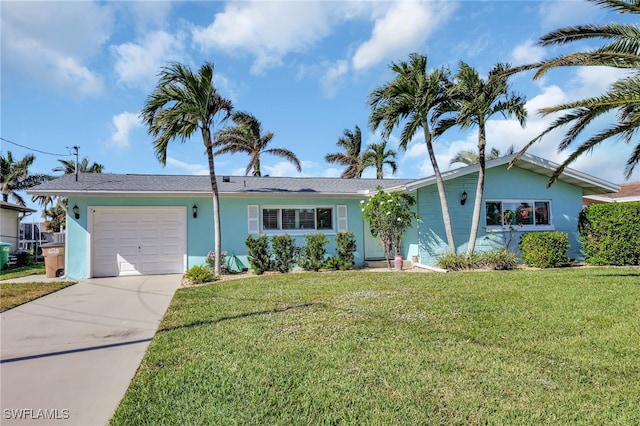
[352,0,455,70]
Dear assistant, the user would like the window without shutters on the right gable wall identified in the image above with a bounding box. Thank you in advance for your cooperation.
[485,200,551,229]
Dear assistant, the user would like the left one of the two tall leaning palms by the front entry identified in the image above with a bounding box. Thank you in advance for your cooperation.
[369,53,456,253]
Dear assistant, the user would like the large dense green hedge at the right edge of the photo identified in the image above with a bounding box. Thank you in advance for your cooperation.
[578,202,640,265]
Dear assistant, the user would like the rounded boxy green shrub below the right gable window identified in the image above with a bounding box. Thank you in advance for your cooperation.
[520,231,569,268]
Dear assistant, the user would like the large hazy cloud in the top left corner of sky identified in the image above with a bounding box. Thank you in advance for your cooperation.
[0,2,113,96]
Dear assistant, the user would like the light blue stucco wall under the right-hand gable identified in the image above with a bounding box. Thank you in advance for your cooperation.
[417,165,583,266]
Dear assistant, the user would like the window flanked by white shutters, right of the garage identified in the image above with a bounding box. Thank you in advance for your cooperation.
[262,207,335,232]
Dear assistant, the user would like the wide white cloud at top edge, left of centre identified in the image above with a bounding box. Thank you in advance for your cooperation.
[192,1,344,74]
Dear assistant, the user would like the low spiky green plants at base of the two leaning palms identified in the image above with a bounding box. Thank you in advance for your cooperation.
[437,248,518,271]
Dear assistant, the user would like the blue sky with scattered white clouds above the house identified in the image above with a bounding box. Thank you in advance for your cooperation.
[0,0,640,212]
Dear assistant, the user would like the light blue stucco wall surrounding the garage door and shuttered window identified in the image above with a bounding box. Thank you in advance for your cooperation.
[66,196,364,279]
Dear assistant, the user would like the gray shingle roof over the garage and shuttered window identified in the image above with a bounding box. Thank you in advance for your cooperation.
[28,173,412,195]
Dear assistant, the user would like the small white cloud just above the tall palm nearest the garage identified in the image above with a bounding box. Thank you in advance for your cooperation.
[111,31,186,90]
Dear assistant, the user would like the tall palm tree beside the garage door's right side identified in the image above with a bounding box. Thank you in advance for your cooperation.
[140,62,233,275]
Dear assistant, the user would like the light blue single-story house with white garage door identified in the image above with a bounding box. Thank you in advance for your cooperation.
[28,155,619,279]
